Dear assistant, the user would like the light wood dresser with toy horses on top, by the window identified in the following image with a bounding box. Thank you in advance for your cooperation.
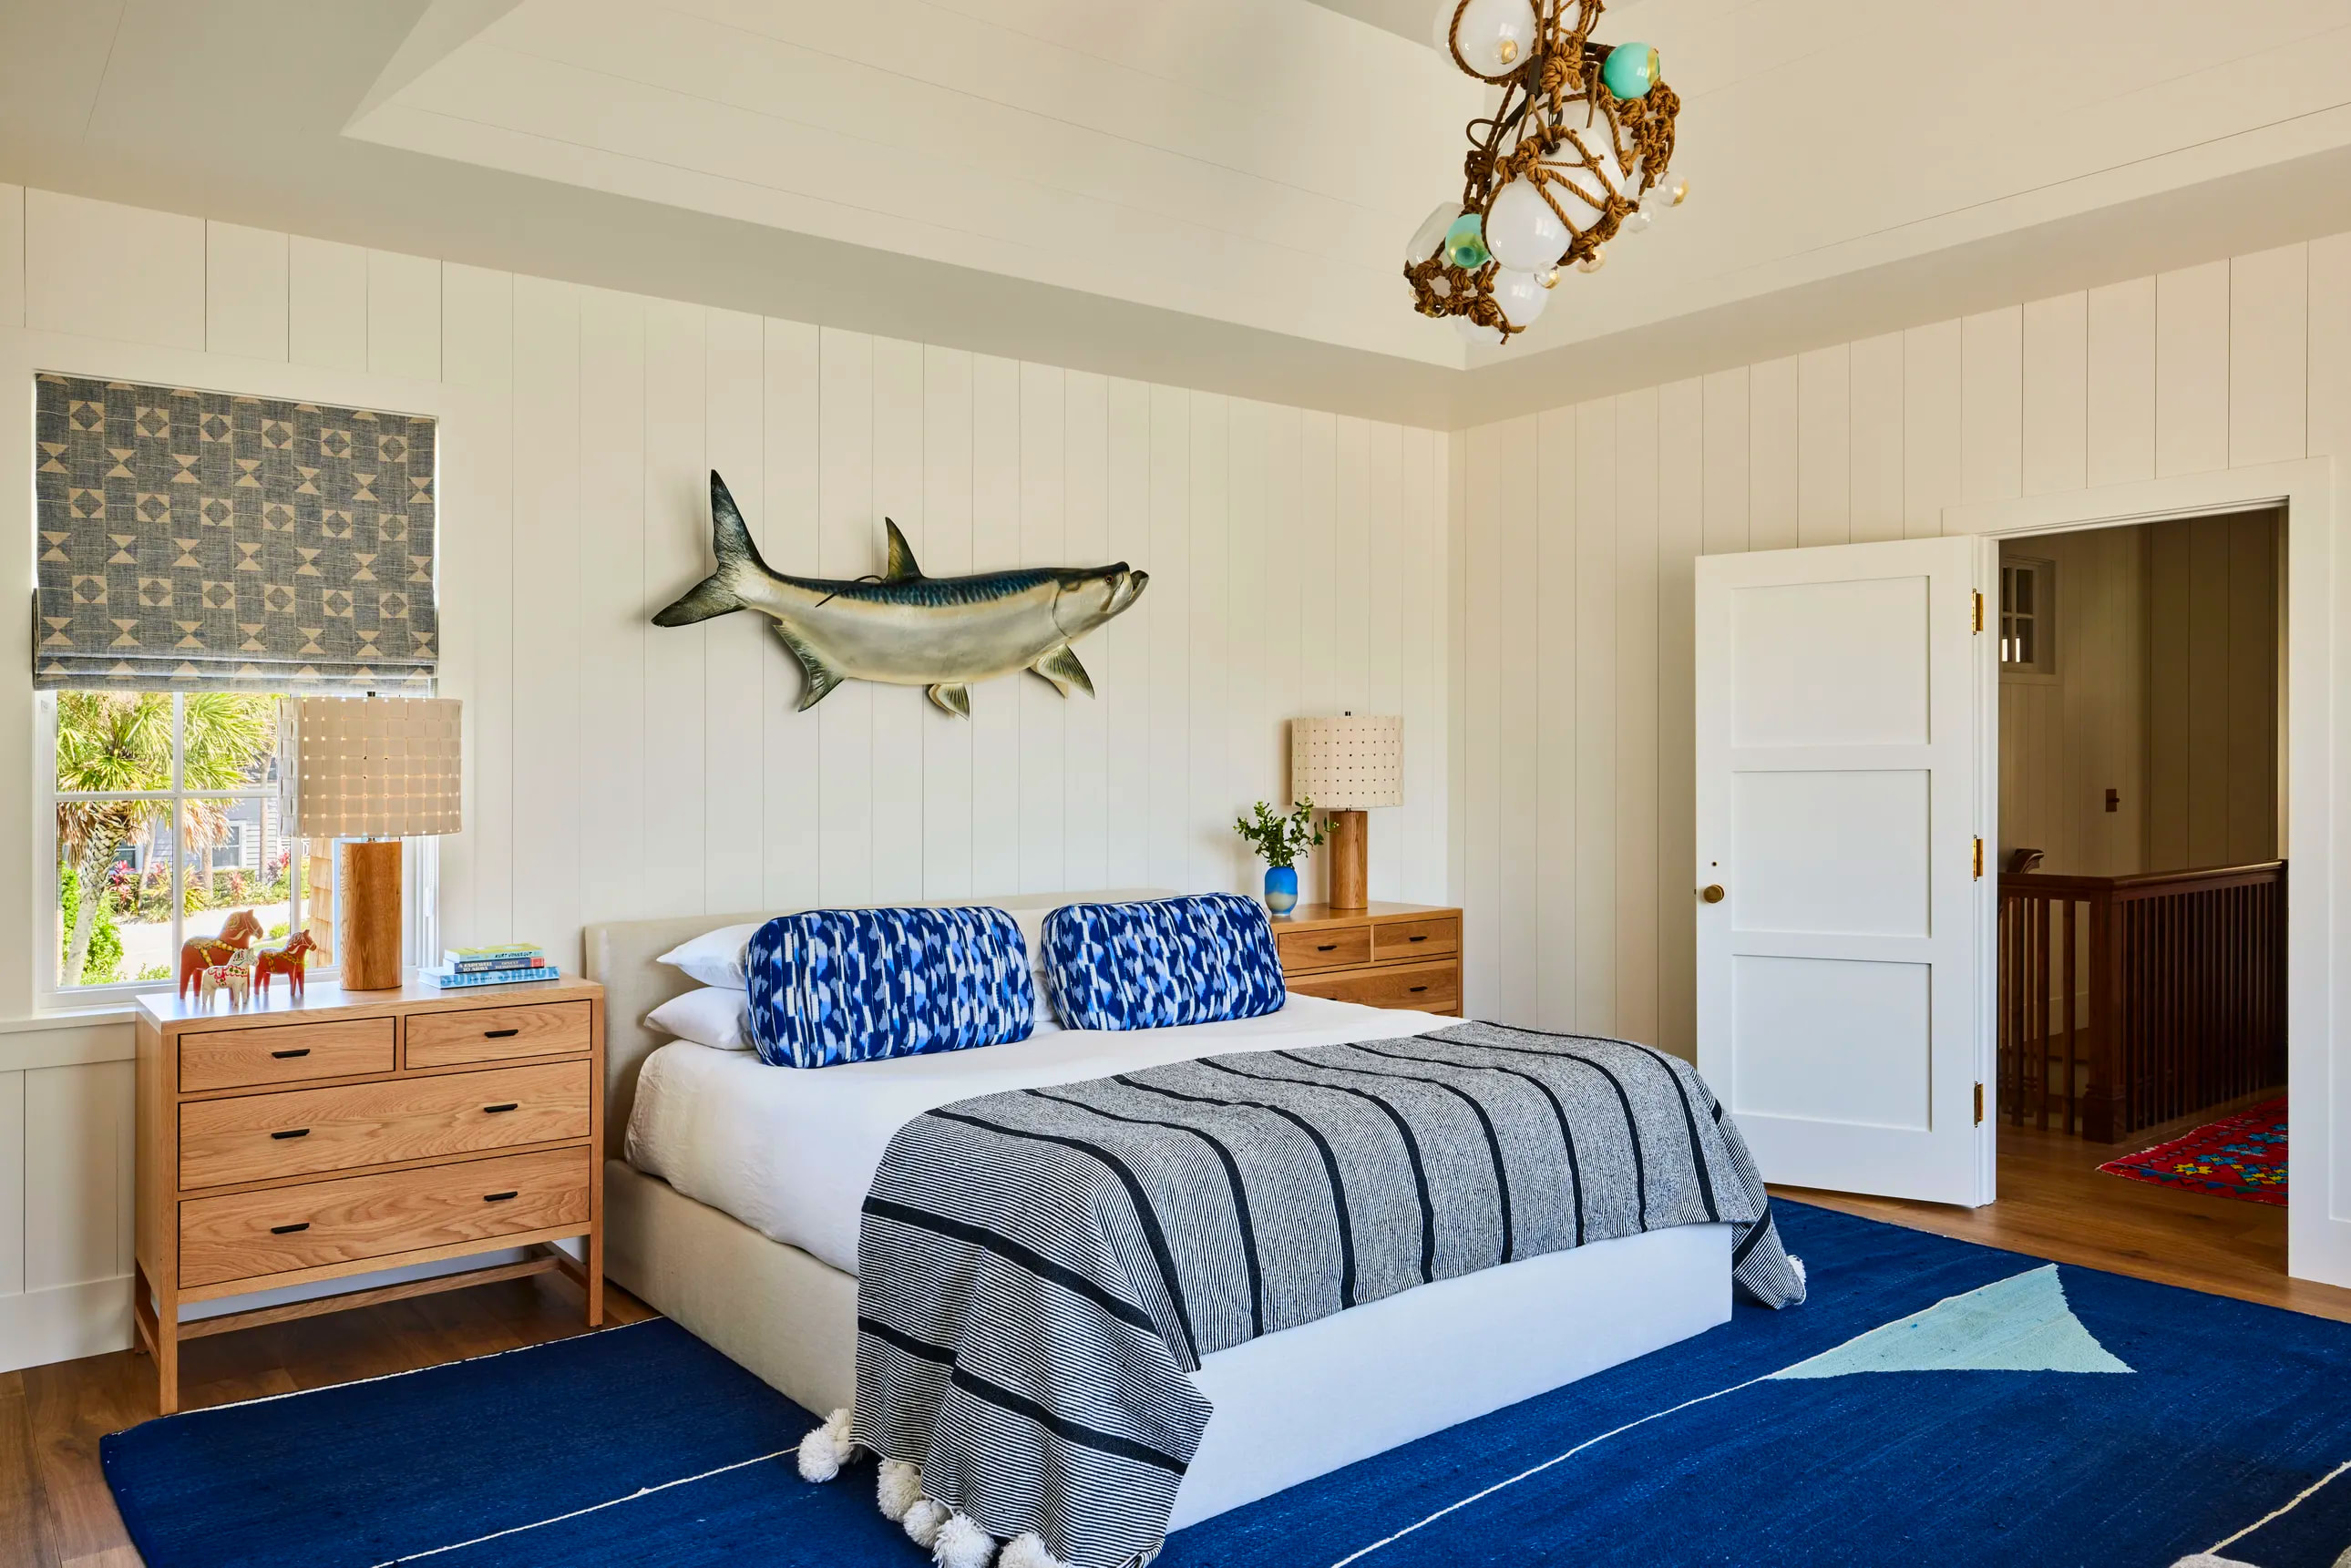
[131,978,604,1415]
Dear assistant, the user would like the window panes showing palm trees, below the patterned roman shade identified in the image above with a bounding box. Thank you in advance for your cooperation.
[40,692,332,997]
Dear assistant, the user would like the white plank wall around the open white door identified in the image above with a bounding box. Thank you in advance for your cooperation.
[1451,235,2351,1053]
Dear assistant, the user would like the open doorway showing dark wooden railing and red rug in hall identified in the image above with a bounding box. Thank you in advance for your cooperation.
[1996,507,2287,1274]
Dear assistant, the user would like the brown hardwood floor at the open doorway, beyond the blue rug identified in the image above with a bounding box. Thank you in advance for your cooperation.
[1772,1091,2351,1324]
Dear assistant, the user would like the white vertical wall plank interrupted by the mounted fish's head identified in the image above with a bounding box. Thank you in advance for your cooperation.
[1061,372,1109,888]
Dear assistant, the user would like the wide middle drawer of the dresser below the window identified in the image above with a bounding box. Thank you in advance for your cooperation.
[179,1062,588,1190]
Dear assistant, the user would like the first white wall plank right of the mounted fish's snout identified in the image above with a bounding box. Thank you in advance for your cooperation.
[1147,385,1194,891]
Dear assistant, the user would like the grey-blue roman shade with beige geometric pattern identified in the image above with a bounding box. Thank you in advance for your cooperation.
[33,374,439,693]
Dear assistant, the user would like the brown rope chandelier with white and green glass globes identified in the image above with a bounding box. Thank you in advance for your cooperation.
[1403,0,1690,343]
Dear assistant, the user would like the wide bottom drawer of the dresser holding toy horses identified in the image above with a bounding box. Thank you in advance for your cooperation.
[179,1147,590,1291]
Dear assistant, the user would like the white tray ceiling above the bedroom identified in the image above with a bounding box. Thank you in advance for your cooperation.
[0,0,2351,423]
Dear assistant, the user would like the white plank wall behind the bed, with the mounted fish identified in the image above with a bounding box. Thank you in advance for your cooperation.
[0,186,1451,1366]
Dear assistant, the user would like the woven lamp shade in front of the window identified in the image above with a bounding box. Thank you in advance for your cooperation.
[287,696,466,839]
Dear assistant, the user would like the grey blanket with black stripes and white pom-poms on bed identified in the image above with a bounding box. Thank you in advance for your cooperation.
[851,1022,1803,1568]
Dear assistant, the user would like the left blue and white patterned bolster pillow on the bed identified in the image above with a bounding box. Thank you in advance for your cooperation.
[745,907,1037,1067]
